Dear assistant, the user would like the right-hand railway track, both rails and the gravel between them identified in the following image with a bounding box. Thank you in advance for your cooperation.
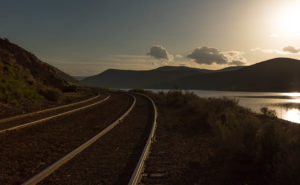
[15,94,157,185]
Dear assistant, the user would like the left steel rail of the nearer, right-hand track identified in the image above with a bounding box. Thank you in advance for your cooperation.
[22,95,136,185]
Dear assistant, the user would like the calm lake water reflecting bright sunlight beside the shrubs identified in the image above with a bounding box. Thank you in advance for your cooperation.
[152,90,300,123]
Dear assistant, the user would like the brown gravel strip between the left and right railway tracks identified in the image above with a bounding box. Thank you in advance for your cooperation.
[0,93,132,184]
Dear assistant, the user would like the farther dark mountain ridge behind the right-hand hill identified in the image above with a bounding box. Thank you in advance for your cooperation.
[82,66,244,89]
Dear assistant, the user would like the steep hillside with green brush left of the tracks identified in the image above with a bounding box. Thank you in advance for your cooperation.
[0,38,99,119]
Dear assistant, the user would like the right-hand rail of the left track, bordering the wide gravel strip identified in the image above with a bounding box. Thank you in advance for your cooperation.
[0,94,111,134]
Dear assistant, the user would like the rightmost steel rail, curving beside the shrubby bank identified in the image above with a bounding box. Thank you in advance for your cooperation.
[128,93,157,185]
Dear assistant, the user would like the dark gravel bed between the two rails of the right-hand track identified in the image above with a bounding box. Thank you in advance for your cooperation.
[29,95,155,185]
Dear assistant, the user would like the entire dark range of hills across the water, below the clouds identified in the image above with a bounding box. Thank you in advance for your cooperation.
[82,58,300,91]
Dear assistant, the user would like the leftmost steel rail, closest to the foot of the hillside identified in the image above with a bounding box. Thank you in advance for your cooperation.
[0,94,100,123]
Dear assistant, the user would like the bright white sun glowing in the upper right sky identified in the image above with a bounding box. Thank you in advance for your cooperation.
[274,3,300,37]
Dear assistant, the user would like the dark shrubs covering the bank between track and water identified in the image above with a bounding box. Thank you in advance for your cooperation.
[152,91,300,185]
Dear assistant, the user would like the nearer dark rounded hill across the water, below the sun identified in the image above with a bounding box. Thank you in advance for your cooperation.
[158,58,300,91]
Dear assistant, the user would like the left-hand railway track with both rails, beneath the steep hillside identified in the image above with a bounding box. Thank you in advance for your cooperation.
[0,95,110,134]
